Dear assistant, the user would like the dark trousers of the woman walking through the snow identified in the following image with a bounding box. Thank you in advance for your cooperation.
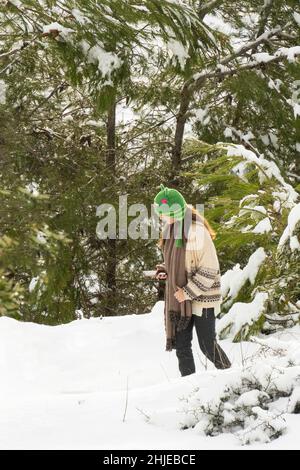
[176,307,231,376]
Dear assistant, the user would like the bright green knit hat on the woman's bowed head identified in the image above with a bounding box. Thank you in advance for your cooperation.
[154,184,187,247]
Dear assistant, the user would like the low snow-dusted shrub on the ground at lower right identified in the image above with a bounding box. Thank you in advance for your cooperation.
[180,339,300,445]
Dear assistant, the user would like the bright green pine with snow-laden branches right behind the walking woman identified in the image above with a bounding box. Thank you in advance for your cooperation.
[180,139,300,340]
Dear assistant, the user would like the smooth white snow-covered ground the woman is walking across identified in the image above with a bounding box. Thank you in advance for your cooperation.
[0,302,300,449]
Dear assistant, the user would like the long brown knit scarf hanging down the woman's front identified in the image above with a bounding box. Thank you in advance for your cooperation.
[162,209,192,351]
